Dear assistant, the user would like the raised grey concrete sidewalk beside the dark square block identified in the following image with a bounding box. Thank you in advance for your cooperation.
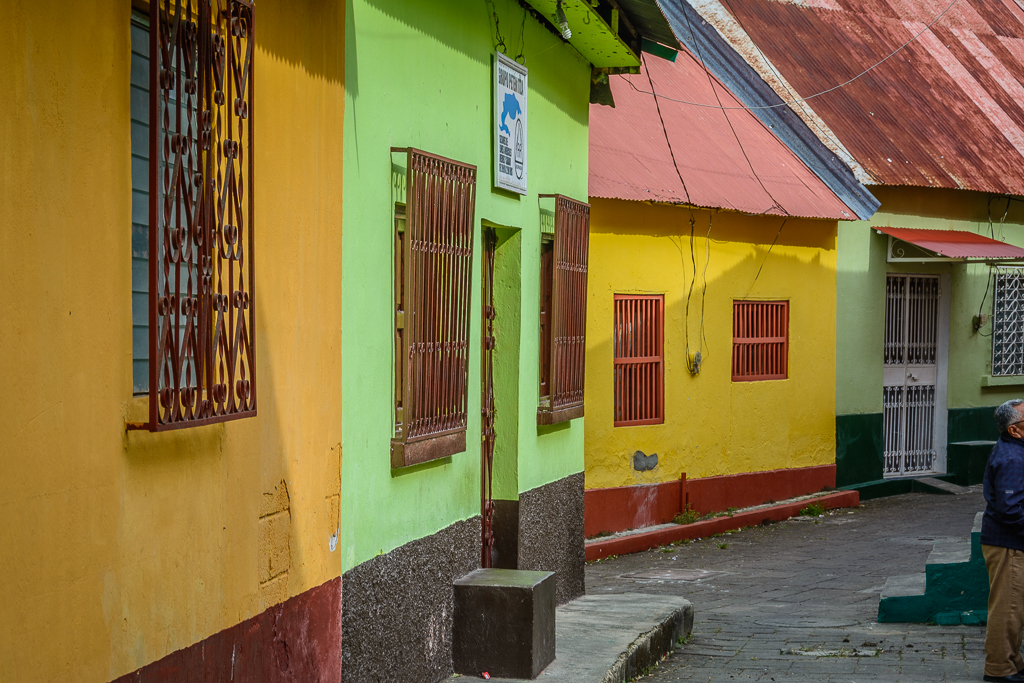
[450,592,693,683]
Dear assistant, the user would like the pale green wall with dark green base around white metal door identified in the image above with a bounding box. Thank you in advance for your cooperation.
[836,186,1024,486]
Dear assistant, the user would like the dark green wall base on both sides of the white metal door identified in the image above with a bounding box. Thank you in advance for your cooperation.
[836,405,999,489]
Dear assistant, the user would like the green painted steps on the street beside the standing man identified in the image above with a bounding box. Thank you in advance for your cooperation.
[879,512,988,625]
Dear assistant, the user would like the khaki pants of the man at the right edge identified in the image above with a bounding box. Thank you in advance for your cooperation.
[981,546,1024,676]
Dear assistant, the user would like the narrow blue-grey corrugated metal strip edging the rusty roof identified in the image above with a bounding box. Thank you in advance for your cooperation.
[658,0,879,220]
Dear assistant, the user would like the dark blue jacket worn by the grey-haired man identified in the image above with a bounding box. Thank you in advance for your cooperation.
[981,434,1024,550]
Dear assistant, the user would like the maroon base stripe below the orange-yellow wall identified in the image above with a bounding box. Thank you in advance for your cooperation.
[114,577,341,683]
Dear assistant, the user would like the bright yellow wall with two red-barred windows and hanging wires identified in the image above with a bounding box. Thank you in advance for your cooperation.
[586,199,837,488]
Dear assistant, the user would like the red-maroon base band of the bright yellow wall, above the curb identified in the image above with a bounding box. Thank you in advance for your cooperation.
[584,465,836,538]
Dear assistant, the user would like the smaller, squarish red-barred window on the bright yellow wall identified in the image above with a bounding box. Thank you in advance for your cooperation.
[732,301,790,382]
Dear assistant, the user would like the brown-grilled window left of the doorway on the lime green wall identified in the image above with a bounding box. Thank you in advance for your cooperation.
[391,148,476,467]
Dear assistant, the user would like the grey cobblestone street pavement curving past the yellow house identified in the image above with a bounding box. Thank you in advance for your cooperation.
[587,486,985,683]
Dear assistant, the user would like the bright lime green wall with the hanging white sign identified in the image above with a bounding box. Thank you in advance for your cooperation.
[341,0,590,570]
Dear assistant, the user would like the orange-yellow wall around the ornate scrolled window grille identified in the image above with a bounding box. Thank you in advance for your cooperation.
[0,0,344,682]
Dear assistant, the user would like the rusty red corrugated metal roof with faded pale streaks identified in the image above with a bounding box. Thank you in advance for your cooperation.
[723,0,1024,195]
